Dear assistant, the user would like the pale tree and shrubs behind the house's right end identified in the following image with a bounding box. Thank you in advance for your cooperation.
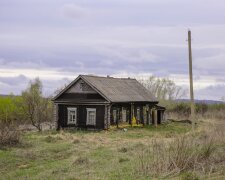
[139,76,225,119]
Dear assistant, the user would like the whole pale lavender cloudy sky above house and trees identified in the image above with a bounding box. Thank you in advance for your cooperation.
[0,0,225,100]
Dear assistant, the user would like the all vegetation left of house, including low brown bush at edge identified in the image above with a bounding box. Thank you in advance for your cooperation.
[0,79,53,146]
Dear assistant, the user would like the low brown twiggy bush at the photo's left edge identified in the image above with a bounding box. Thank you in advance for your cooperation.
[0,122,21,146]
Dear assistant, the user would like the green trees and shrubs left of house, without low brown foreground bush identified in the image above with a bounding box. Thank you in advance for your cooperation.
[0,78,53,131]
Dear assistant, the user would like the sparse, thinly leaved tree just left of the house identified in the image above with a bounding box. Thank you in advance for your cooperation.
[22,78,52,131]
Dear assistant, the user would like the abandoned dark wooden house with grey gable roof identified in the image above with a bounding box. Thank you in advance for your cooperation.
[53,75,165,129]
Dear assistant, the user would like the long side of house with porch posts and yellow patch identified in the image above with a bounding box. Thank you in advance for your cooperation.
[104,103,165,128]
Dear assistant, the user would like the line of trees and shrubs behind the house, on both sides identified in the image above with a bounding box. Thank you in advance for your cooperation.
[0,76,225,131]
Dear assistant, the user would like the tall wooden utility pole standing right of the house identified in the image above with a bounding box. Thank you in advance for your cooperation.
[188,30,195,128]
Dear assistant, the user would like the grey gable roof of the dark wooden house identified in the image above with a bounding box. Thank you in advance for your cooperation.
[53,75,158,102]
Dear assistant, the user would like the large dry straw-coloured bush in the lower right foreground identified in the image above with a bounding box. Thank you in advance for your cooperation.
[137,133,225,177]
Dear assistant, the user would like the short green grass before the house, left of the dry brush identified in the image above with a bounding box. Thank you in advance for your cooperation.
[0,122,223,179]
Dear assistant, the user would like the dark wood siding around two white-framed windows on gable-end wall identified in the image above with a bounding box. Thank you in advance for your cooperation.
[58,104,105,129]
